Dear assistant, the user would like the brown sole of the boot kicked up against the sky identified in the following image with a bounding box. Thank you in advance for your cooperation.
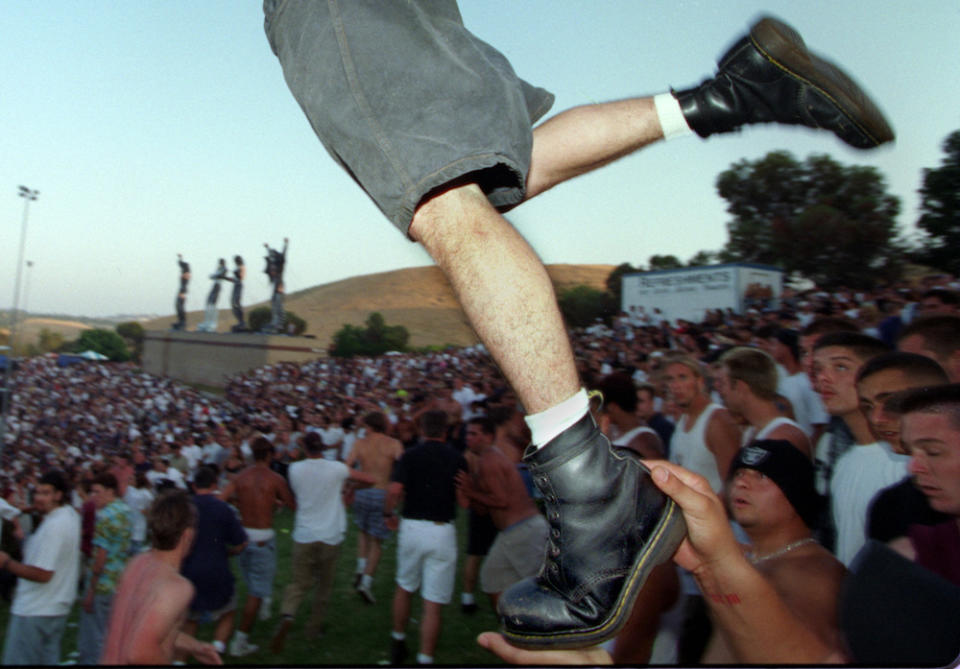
[750,17,894,146]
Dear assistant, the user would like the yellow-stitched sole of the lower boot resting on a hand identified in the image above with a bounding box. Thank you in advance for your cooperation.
[501,483,687,650]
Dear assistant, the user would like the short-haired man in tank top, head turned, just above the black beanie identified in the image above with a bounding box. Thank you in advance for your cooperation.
[714,346,812,457]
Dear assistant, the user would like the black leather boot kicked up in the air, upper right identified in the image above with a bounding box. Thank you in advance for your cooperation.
[674,17,893,149]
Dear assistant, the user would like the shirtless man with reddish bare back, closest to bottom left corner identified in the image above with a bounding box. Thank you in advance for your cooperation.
[100,491,222,665]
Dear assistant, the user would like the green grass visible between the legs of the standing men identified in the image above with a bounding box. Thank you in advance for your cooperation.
[0,509,502,666]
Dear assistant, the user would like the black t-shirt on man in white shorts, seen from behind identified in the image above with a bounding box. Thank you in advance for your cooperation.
[391,441,467,523]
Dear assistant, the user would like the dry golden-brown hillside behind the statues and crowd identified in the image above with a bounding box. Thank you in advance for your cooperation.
[143,265,615,346]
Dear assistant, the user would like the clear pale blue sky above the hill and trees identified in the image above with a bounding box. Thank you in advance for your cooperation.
[0,0,960,316]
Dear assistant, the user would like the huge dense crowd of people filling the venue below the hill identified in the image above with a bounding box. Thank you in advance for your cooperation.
[0,276,960,664]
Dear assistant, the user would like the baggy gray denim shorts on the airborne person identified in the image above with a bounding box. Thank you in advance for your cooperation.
[263,0,553,234]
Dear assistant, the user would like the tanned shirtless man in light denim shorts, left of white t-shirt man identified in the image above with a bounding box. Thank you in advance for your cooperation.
[220,437,297,657]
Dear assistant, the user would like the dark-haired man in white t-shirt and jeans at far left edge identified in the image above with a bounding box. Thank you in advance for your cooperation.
[0,470,80,666]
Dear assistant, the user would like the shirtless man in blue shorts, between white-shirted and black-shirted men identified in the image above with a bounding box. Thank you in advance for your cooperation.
[347,411,403,604]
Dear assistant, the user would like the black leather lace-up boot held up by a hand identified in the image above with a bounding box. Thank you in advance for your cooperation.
[497,414,686,648]
